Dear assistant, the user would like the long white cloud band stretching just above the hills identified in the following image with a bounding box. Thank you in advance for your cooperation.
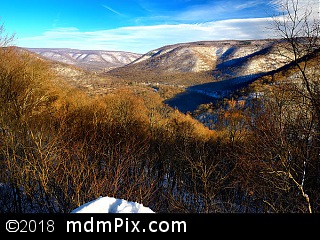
[16,18,278,53]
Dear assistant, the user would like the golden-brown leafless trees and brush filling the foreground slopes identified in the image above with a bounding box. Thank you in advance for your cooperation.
[0,0,320,213]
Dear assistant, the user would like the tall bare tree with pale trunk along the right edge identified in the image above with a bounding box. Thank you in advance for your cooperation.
[273,0,320,213]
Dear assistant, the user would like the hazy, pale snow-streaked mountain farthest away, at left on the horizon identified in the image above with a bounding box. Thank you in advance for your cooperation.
[26,48,141,71]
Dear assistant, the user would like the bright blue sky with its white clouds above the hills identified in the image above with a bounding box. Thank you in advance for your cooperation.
[0,0,318,53]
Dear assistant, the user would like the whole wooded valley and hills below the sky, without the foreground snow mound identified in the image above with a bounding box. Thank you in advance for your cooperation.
[0,34,320,213]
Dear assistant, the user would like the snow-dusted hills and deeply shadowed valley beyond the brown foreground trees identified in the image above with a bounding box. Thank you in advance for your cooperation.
[28,39,296,113]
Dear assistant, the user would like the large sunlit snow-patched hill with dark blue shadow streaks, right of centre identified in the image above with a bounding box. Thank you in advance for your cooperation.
[109,39,289,86]
